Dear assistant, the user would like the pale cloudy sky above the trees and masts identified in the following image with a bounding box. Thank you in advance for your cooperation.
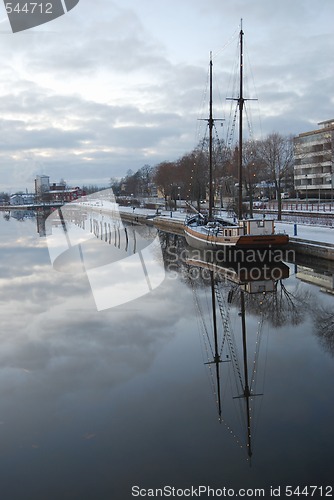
[0,0,334,192]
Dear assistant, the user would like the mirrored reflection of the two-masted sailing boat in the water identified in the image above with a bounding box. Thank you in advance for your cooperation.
[186,251,289,460]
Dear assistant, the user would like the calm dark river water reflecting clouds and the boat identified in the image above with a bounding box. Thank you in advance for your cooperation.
[0,212,334,500]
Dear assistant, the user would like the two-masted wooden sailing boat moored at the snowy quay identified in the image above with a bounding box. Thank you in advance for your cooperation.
[184,23,289,250]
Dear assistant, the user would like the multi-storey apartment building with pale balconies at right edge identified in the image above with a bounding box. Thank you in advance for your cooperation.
[294,119,334,198]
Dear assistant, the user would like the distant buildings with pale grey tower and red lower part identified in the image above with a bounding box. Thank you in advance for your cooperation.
[35,175,86,203]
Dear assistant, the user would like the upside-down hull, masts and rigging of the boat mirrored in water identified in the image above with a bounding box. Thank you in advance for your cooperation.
[186,250,289,460]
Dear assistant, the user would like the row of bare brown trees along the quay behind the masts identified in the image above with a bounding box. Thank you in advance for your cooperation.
[110,132,294,220]
